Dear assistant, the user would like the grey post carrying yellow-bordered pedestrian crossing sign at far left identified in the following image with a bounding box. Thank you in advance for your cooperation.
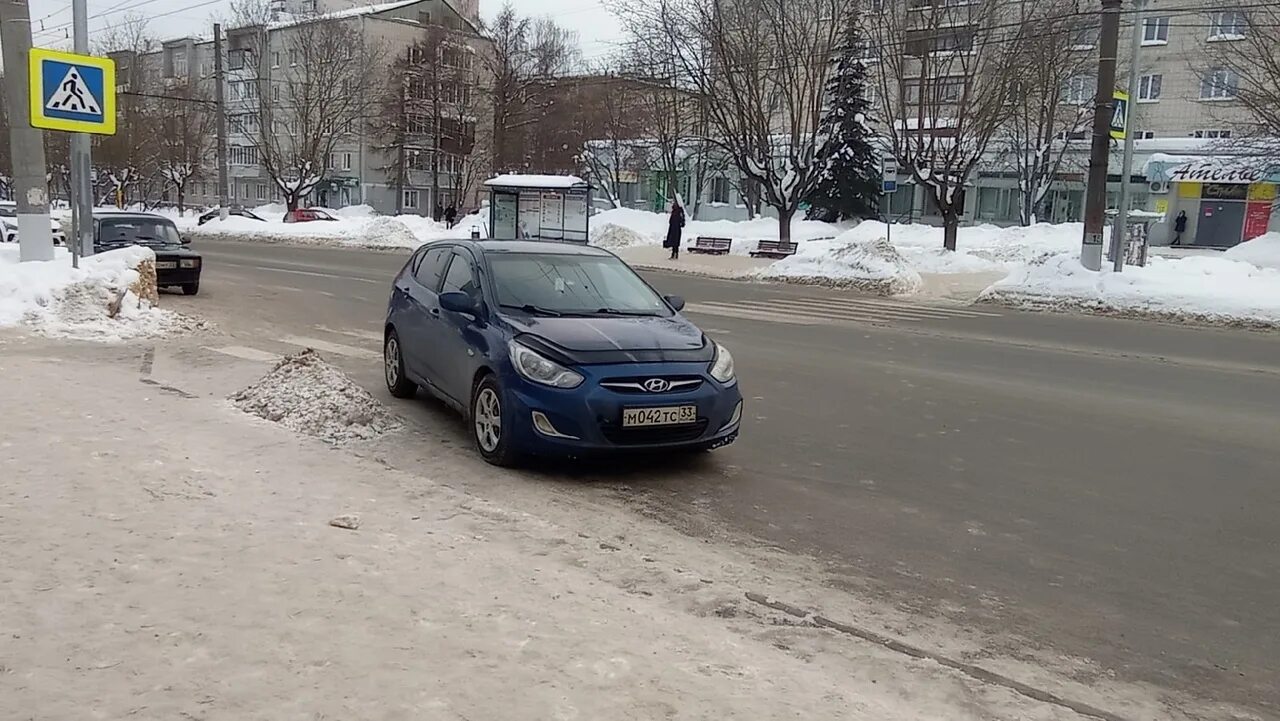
[28,43,115,266]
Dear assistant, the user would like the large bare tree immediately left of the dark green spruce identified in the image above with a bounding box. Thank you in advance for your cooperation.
[614,0,850,239]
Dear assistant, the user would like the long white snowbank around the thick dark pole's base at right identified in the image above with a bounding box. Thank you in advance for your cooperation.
[980,252,1280,327]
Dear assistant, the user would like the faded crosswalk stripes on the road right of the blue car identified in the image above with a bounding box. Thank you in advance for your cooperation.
[686,297,1000,325]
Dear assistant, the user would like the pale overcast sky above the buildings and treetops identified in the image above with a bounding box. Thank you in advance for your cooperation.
[28,0,621,59]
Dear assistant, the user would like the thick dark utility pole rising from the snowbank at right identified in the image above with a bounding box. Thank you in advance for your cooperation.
[1080,0,1123,270]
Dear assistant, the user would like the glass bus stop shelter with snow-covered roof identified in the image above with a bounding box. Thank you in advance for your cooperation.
[484,174,590,243]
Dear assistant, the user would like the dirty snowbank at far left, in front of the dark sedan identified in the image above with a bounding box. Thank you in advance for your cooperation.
[0,246,182,341]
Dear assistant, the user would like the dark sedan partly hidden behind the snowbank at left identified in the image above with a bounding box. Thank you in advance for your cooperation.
[93,213,204,296]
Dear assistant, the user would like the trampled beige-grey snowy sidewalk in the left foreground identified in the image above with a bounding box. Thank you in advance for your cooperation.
[0,342,1167,721]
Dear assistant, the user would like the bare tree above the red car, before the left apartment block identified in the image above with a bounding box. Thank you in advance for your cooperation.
[246,18,387,210]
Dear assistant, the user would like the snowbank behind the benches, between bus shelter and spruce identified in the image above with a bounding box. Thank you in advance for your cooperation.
[590,207,844,255]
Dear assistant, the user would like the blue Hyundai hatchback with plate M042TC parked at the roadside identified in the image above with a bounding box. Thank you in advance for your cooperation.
[383,241,742,465]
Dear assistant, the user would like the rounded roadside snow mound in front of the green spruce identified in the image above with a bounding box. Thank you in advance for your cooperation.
[758,229,923,296]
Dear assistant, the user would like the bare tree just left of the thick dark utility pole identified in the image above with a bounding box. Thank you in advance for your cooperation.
[996,7,1100,225]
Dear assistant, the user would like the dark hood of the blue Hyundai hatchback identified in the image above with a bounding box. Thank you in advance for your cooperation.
[503,314,716,364]
